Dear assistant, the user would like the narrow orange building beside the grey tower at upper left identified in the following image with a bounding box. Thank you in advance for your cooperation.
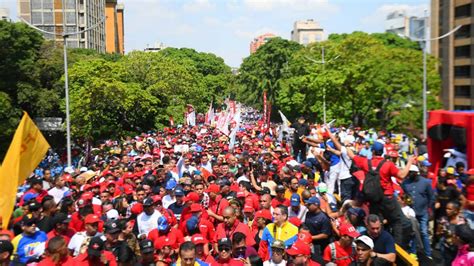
[105,0,124,54]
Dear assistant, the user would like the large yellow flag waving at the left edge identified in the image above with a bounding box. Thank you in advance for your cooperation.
[0,112,49,228]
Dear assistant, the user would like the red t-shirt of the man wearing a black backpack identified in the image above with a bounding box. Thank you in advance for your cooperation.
[354,156,399,196]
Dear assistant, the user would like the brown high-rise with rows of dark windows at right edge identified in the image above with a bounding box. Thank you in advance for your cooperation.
[431,0,474,110]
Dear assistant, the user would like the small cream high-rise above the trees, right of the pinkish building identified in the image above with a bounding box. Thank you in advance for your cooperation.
[291,19,324,45]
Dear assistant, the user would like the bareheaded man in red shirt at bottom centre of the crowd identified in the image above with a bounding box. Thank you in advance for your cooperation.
[214,206,255,249]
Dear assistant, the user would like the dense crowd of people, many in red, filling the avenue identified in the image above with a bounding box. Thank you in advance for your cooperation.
[0,115,474,266]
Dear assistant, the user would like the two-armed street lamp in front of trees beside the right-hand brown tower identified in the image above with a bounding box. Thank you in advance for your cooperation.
[399,12,462,139]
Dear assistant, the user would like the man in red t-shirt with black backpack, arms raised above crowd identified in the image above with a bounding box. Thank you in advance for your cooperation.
[347,141,414,248]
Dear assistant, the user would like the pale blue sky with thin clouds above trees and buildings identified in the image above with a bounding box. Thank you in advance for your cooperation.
[0,0,429,67]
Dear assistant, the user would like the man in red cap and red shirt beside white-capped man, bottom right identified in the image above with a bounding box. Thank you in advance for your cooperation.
[323,223,360,266]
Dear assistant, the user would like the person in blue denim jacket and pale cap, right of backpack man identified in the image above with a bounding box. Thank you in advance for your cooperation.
[402,165,434,257]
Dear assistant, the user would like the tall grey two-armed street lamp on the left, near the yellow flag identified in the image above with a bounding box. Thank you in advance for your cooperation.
[20,4,105,167]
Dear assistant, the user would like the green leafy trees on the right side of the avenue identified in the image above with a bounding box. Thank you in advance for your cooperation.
[239,32,440,130]
